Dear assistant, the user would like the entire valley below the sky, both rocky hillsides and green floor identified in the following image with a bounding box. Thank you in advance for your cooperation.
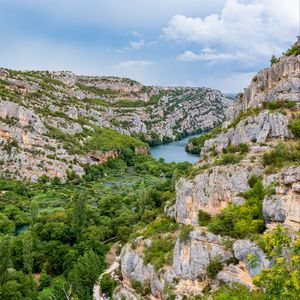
[0,40,300,300]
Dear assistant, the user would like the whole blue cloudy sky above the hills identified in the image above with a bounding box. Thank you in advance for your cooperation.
[0,0,300,93]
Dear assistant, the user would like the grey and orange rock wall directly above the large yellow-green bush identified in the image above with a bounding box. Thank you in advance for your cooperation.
[168,165,262,225]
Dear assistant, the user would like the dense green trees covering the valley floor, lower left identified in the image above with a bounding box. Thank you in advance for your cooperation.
[0,153,191,300]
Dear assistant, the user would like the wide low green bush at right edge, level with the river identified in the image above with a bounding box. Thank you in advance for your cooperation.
[262,143,300,168]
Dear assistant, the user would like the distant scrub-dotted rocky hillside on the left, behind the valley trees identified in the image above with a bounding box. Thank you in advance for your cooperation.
[0,69,230,180]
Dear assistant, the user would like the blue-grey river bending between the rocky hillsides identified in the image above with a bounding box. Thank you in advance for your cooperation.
[150,134,201,163]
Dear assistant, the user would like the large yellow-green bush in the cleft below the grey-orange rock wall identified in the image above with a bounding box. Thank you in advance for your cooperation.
[208,180,266,238]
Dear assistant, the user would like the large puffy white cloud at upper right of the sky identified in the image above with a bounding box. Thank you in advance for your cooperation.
[163,0,299,61]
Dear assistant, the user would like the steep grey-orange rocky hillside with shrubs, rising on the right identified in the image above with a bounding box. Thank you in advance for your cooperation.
[115,41,300,299]
